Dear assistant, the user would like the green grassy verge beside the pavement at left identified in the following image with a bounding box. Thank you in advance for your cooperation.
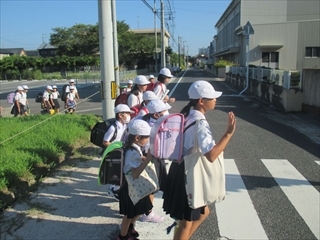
[0,114,99,209]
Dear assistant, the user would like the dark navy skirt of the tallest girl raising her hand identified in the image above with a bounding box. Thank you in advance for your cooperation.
[163,162,205,221]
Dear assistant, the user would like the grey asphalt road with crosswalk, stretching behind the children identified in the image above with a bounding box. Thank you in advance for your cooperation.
[1,69,320,239]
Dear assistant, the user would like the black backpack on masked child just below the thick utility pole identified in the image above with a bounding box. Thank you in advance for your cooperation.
[90,118,117,148]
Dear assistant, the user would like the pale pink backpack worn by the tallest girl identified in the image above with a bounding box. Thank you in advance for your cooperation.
[150,113,184,162]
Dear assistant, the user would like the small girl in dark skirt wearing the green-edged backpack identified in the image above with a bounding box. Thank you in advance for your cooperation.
[117,119,153,240]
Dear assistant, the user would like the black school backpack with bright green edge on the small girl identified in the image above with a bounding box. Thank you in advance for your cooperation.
[98,141,134,186]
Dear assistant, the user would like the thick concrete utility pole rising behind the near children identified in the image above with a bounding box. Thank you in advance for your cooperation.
[98,0,114,120]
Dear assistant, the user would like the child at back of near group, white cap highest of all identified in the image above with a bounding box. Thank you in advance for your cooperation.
[153,68,176,103]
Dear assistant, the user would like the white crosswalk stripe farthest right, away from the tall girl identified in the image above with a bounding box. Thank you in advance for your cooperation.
[261,159,320,239]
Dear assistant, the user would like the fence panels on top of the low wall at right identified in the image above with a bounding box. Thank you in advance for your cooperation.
[226,66,302,89]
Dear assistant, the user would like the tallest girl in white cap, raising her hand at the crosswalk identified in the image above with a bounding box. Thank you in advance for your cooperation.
[163,81,236,240]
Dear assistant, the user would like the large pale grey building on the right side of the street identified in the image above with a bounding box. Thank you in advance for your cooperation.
[213,0,320,70]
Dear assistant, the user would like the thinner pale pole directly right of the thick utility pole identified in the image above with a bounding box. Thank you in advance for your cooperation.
[111,0,120,96]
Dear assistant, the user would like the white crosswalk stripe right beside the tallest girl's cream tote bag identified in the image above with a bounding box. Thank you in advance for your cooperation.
[216,159,268,239]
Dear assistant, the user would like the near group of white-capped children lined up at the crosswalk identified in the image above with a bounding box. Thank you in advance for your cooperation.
[103,68,236,240]
